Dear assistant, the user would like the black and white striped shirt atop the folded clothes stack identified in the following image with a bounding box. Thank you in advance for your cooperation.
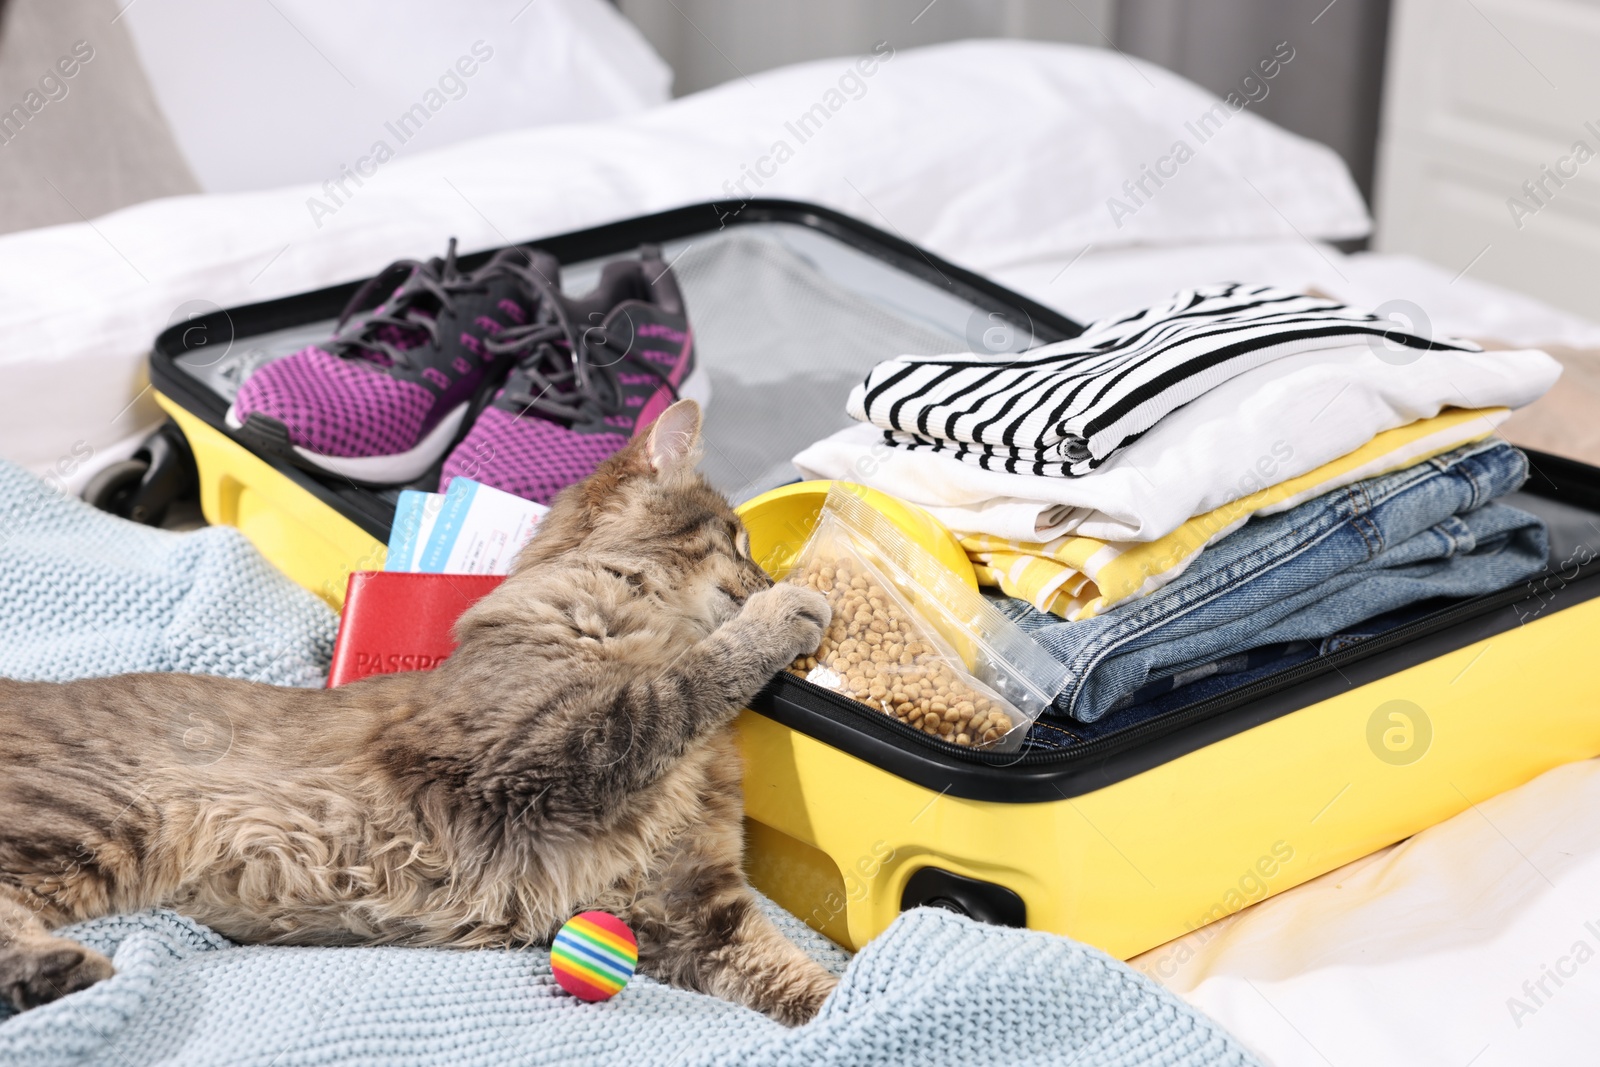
[848,283,1478,477]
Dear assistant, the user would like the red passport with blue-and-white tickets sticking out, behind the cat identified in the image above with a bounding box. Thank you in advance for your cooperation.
[328,571,506,686]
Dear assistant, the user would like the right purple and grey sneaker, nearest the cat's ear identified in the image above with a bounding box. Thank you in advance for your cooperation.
[438,246,710,504]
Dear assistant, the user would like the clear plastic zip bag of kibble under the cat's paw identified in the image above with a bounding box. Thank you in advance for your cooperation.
[784,483,1067,752]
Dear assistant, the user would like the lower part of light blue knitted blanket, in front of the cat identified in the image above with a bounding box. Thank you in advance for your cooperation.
[0,909,1256,1067]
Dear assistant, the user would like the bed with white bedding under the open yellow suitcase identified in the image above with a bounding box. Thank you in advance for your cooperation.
[0,29,1600,1067]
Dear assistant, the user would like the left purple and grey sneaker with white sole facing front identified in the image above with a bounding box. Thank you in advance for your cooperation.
[227,240,558,485]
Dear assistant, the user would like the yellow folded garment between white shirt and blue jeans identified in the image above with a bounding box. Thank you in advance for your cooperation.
[957,408,1510,622]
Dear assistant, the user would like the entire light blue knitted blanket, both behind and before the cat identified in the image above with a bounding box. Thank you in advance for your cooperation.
[0,464,1258,1067]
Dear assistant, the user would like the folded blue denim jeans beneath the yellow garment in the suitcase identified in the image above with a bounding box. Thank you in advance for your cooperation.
[1000,442,1547,721]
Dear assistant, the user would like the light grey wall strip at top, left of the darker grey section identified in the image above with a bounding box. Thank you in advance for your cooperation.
[618,0,1115,96]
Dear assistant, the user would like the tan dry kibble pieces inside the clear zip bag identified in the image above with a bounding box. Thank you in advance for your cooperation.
[789,558,1011,745]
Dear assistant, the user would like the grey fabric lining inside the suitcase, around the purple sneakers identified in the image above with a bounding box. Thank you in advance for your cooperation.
[176,222,1035,504]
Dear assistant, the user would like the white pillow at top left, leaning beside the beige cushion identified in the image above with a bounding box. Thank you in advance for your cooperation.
[118,0,672,192]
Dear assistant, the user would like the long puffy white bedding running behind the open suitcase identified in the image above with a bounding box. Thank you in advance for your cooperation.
[0,37,1368,489]
